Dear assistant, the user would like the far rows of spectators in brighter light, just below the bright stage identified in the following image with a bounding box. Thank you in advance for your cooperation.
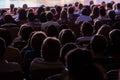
[0,0,120,29]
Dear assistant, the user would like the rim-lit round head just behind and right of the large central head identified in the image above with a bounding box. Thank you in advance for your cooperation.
[58,29,76,45]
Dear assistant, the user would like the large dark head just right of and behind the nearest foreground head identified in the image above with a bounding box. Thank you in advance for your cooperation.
[90,35,108,56]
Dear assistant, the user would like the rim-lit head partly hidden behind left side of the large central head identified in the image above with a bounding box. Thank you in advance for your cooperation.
[30,31,47,50]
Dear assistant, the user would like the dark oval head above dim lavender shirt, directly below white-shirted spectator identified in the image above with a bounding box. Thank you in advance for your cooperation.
[80,22,93,36]
